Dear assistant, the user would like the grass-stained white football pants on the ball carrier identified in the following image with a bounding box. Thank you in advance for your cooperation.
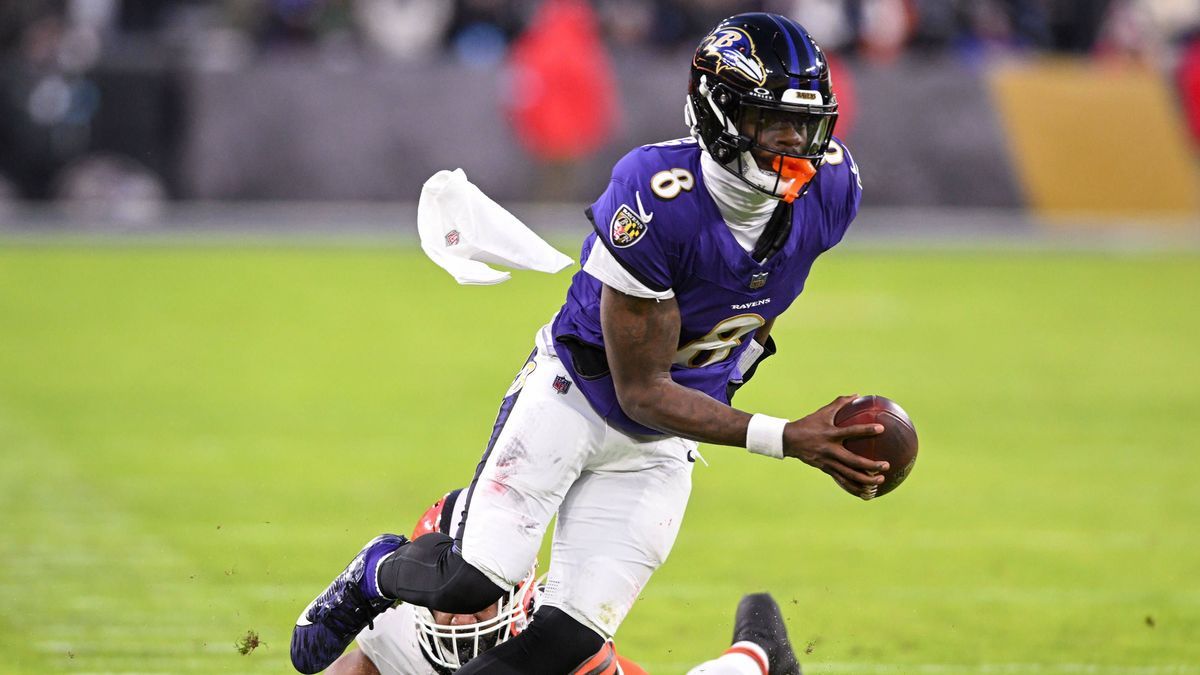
[462,325,696,639]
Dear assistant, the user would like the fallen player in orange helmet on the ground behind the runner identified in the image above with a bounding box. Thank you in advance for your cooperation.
[312,490,799,675]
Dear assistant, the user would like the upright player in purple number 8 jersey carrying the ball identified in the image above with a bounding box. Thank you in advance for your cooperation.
[292,13,888,675]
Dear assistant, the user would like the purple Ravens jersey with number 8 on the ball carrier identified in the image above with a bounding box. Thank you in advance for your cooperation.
[553,139,862,434]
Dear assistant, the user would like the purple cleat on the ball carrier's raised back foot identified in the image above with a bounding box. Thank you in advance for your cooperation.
[292,534,408,673]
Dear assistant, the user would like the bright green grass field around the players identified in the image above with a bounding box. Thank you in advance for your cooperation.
[0,239,1200,675]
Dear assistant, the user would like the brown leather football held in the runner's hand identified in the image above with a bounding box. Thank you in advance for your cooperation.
[833,396,917,497]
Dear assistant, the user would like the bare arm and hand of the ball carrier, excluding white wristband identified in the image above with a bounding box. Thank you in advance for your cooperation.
[600,286,887,487]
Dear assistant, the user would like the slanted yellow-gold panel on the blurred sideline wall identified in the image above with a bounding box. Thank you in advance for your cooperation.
[989,59,1200,226]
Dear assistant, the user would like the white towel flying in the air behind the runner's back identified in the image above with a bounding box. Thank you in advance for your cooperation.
[416,169,575,285]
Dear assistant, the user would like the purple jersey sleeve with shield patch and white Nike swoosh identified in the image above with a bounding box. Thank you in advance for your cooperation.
[587,150,678,293]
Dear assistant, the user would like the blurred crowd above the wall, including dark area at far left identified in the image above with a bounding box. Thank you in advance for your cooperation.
[0,0,1200,210]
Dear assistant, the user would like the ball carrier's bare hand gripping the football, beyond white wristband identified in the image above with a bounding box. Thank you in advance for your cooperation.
[784,396,888,500]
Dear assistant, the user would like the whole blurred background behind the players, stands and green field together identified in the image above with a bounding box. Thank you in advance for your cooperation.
[0,0,1200,675]
